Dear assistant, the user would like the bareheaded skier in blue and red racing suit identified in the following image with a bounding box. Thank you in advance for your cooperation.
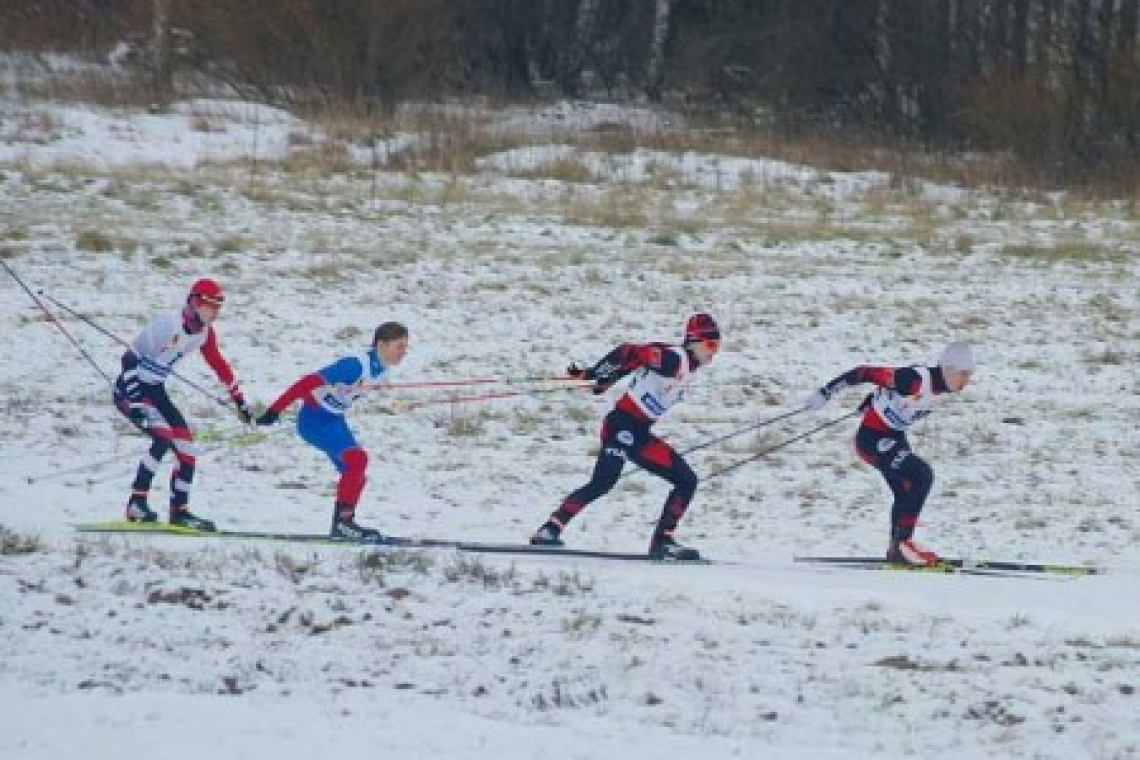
[257,322,408,544]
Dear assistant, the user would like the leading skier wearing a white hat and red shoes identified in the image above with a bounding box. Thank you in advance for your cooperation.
[804,342,975,565]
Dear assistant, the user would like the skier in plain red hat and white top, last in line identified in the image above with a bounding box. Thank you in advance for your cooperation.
[113,278,252,531]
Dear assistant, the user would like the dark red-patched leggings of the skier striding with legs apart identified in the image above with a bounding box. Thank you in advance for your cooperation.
[551,409,698,539]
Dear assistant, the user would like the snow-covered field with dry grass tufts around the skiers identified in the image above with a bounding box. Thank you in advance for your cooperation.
[0,90,1140,760]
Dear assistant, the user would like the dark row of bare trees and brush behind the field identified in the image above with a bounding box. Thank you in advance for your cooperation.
[0,0,1140,182]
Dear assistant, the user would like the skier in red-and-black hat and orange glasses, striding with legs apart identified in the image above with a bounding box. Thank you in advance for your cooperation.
[530,312,720,559]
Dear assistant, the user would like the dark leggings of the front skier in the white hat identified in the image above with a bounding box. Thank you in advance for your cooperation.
[855,425,934,540]
